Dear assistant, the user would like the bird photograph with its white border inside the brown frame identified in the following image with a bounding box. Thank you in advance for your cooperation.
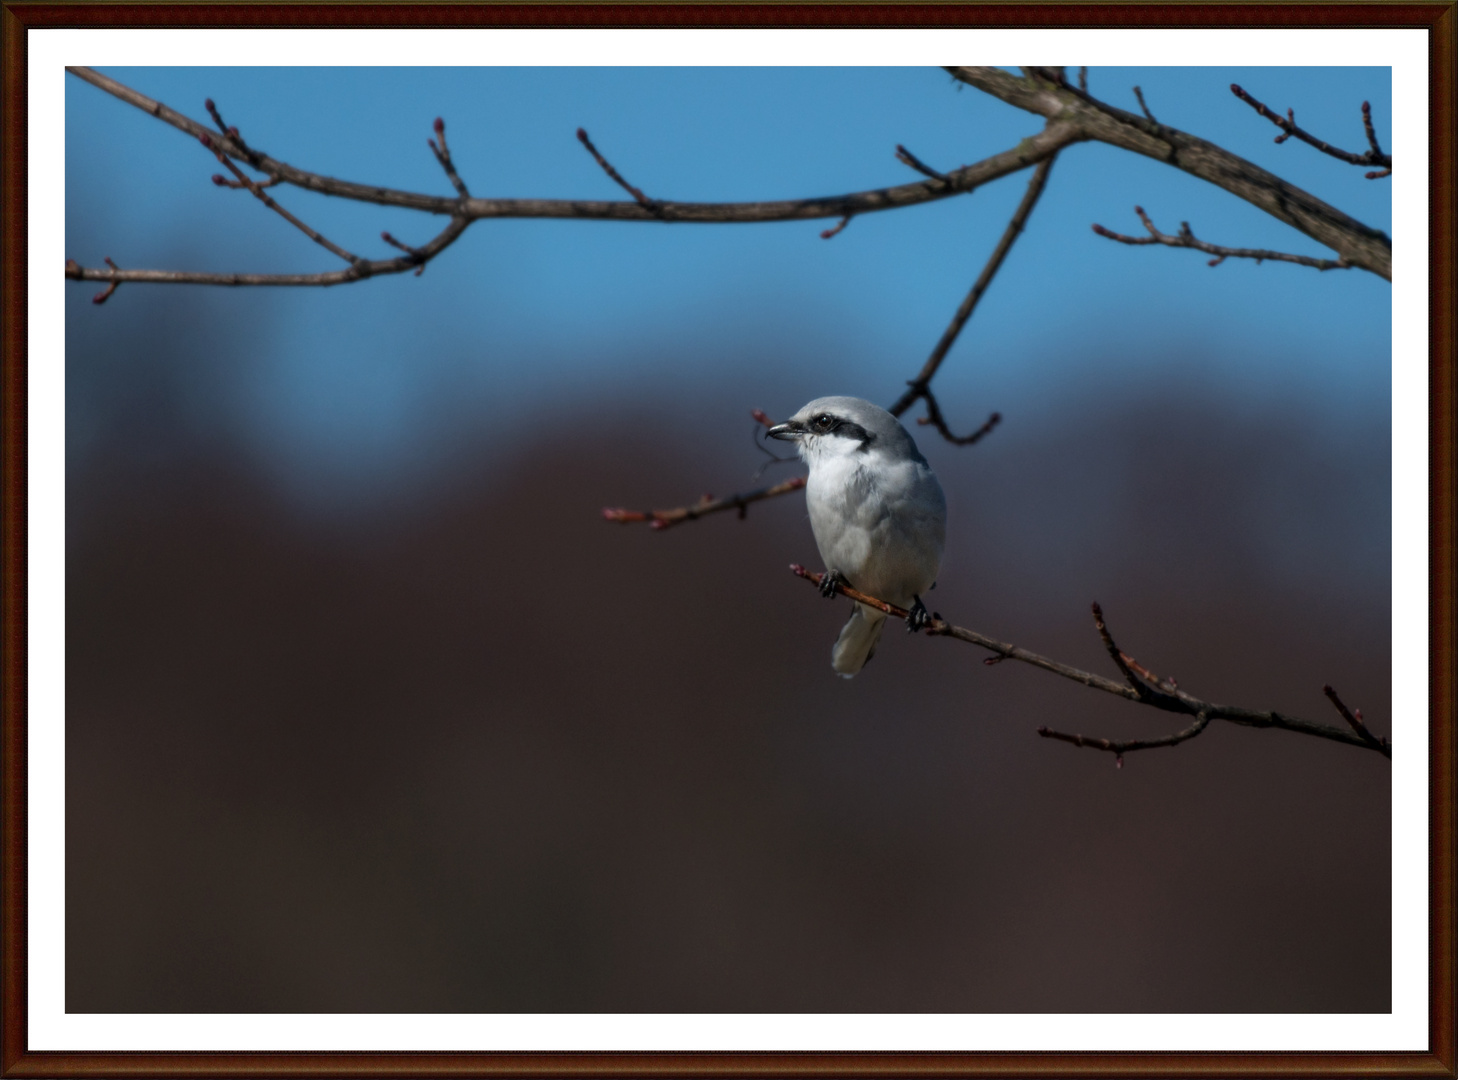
[2,16,1451,1072]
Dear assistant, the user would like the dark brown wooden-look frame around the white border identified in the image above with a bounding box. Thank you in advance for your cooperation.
[0,0,1458,1077]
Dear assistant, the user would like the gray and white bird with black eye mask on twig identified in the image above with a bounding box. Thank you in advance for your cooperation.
[768,398,946,679]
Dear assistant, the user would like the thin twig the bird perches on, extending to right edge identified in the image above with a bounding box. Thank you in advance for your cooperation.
[790,563,1392,758]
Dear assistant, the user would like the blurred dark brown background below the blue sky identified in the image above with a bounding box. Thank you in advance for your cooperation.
[66,298,1391,1011]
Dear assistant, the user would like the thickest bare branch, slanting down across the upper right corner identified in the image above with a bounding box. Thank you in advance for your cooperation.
[946,67,1392,281]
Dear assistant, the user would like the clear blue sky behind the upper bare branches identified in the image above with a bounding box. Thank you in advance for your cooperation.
[66,67,1391,497]
